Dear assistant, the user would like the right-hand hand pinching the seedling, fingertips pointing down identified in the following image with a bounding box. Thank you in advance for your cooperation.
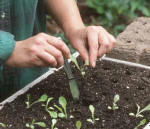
[66,26,116,67]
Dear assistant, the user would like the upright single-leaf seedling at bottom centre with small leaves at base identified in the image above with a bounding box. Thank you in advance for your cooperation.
[87,105,99,124]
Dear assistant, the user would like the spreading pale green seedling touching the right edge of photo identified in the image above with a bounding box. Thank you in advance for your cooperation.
[129,104,150,117]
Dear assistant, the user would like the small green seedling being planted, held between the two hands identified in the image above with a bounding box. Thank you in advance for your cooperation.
[70,55,90,77]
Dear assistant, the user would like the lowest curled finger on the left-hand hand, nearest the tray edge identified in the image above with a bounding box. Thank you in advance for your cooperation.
[38,52,57,67]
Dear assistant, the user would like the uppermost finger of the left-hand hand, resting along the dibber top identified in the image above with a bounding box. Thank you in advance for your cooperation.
[43,35,70,58]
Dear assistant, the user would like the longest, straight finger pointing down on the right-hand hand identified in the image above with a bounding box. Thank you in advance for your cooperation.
[88,31,98,67]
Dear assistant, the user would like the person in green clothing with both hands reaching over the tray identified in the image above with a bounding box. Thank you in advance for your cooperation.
[0,0,116,98]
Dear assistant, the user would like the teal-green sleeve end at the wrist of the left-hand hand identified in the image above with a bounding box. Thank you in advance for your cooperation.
[0,31,15,65]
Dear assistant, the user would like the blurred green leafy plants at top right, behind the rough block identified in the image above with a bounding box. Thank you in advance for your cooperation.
[86,0,150,35]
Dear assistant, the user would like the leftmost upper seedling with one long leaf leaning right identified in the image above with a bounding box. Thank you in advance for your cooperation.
[26,94,48,109]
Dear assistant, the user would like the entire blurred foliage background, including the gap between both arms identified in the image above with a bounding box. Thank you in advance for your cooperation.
[47,0,150,52]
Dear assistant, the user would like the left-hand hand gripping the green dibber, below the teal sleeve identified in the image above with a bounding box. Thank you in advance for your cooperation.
[5,33,70,67]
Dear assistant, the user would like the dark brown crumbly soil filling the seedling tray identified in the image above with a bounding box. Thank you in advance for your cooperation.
[0,57,150,129]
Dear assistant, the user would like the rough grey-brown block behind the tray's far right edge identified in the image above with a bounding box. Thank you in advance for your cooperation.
[108,17,150,65]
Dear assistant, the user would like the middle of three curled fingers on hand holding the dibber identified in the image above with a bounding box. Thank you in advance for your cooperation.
[45,44,64,67]
